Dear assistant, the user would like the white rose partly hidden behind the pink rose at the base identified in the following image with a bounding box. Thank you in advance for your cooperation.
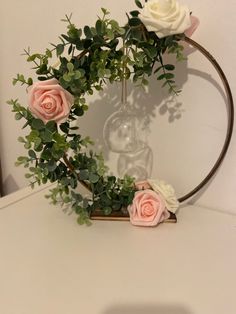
[147,179,179,213]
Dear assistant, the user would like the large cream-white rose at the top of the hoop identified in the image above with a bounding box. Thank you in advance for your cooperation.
[139,0,191,38]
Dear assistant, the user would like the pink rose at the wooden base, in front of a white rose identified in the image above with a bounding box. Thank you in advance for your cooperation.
[128,190,169,226]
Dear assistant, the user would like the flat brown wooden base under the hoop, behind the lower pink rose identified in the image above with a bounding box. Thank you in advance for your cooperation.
[90,209,177,223]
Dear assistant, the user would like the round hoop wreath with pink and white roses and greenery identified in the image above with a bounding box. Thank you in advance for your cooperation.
[8,0,234,226]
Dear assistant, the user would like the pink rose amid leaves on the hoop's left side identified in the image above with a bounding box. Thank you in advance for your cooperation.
[28,78,74,123]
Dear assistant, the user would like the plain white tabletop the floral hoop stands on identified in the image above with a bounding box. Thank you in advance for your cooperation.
[0,185,236,314]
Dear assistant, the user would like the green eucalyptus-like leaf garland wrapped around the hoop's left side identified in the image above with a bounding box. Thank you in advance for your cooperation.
[8,0,191,224]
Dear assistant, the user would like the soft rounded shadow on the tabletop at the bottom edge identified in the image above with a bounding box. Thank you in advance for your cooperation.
[102,304,193,314]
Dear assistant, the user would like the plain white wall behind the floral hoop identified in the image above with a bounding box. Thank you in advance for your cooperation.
[0,0,236,213]
